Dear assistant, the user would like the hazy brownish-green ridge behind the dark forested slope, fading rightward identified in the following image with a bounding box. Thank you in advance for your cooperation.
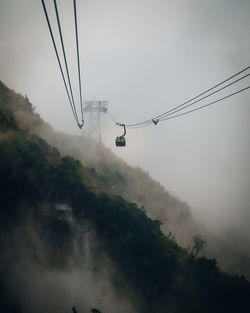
[0,79,199,246]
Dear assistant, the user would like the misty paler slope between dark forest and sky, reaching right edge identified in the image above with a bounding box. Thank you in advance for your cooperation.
[2,81,250,278]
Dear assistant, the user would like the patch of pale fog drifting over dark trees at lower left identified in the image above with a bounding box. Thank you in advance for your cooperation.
[0,214,137,313]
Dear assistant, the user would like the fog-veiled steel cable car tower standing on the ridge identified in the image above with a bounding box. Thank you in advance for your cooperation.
[83,101,108,142]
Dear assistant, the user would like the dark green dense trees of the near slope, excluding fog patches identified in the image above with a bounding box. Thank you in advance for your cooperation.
[0,81,250,313]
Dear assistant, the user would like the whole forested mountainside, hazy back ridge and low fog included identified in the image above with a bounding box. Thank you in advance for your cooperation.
[0,83,250,313]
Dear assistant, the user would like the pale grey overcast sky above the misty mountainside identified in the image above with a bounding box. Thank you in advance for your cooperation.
[0,0,250,242]
